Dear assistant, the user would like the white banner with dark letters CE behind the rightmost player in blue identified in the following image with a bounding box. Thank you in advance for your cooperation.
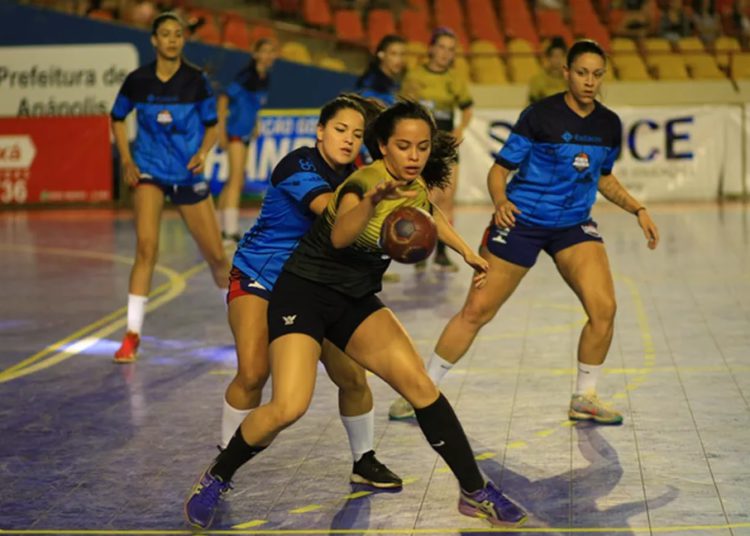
[457,105,750,203]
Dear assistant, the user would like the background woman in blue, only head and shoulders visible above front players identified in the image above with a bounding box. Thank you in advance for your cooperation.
[354,34,406,106]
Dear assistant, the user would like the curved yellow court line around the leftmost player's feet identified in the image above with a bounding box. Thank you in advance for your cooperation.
[0,244,205,383]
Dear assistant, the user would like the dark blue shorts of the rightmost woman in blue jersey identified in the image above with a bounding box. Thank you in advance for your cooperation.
[482,220,604,268]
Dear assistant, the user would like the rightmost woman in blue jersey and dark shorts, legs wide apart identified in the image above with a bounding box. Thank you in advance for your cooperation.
[390,40,659,424]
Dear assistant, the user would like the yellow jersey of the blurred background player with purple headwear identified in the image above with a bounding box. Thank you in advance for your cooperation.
[401,65,474,131]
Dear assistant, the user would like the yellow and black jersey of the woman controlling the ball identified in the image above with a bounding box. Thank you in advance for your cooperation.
[284,160,432,298]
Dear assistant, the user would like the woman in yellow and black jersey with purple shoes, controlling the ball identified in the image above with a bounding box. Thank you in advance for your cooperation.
[186,102,526,528]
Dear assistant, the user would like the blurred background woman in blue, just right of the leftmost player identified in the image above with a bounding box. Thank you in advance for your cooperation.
[217,39,276,243]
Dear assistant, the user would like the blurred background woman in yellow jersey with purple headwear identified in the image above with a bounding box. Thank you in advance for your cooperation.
[402,28,474,272]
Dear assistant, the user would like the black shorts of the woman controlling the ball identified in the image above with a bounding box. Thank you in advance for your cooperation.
[268,272,385,352]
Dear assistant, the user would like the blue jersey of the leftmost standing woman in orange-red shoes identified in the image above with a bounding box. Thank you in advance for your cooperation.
[111,61,216,185]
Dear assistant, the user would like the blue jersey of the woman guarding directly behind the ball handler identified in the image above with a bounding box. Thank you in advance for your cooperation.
[233,147,354,290]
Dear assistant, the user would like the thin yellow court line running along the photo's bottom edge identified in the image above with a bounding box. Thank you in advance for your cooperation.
[0,523,750,536]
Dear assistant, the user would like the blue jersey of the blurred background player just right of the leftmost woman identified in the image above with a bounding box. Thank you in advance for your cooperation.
[225,62,269,141]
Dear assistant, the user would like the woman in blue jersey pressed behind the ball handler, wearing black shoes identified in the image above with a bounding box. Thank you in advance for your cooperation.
[221,95,401,494]
